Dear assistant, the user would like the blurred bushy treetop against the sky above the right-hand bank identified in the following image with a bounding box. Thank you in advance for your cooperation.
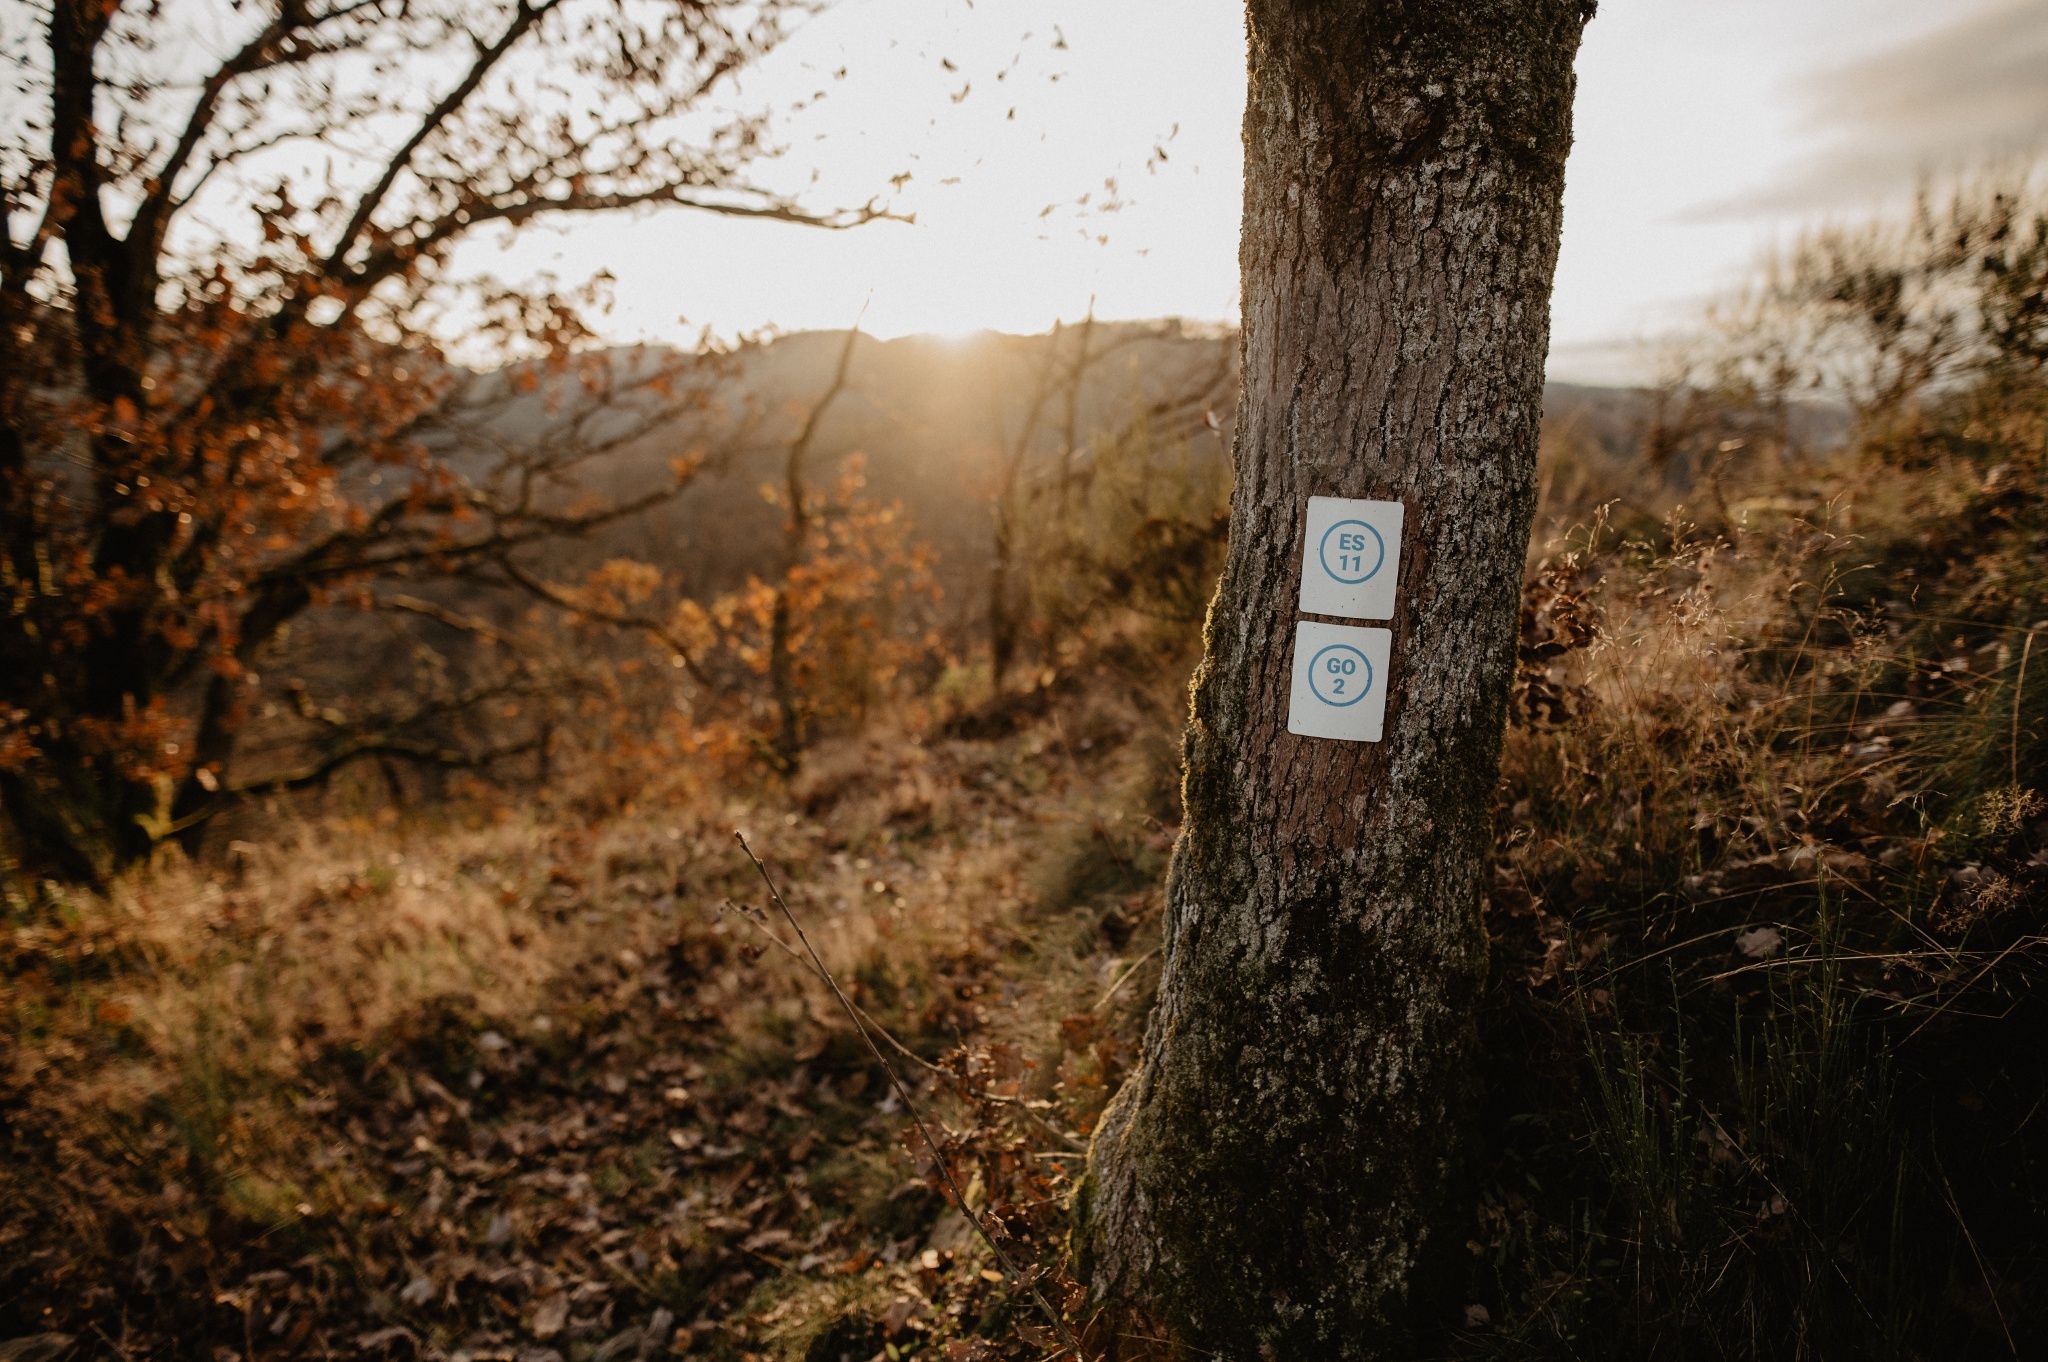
[1605,172,2048,524]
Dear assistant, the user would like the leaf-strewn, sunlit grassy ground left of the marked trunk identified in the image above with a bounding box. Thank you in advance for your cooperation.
[0,667,1176,1362]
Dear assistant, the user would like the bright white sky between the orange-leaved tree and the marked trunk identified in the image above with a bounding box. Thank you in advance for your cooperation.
[454,0,1243,342]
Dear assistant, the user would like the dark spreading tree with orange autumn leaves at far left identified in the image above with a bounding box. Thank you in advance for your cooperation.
[0,0,879,875]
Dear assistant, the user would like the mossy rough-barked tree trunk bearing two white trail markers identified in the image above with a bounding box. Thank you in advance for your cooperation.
[1077,0,1591,1358]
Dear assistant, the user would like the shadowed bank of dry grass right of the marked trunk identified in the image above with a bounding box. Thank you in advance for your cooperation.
[1466,440,2048,1358]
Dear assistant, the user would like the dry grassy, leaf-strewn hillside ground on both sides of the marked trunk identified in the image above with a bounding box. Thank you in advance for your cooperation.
[0,448,2048,1362]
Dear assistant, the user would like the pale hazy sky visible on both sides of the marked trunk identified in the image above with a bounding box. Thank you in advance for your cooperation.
[469,0,2048,381]
